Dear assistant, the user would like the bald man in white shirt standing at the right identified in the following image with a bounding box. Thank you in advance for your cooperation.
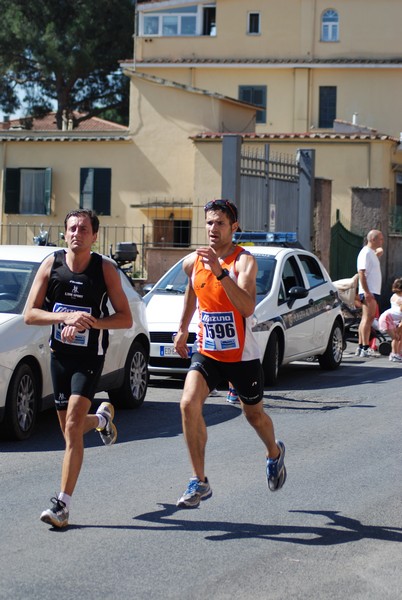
[356,229,384,357]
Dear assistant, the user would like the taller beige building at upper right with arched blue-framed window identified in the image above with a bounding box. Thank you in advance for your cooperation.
[127,0,402,223]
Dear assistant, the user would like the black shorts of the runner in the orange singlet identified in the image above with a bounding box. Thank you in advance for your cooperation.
[189,352,264,404]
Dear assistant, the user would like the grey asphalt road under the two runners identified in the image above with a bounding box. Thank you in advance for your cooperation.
[0,348,402,600]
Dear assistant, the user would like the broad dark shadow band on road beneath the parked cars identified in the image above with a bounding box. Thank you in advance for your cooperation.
[0,355,402,452]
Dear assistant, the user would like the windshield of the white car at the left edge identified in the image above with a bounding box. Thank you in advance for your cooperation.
[0,260,39,314]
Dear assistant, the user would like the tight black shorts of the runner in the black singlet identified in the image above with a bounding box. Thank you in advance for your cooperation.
[50,352,105,410]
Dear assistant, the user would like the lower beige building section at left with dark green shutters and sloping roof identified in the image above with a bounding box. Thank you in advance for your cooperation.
[0,88,255,274]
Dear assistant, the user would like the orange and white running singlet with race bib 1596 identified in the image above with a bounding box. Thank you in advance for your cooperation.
[191,246,260,362]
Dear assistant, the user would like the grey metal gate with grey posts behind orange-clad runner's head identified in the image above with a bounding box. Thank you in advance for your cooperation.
[222,135,314,249]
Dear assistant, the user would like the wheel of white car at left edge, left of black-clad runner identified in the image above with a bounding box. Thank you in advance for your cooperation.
[2,364,38,440]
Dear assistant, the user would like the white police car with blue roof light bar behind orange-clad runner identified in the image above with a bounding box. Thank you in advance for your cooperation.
[144,232,344,385]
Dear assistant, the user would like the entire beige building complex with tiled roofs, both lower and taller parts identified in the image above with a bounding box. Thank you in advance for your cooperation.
[0,0,402,280]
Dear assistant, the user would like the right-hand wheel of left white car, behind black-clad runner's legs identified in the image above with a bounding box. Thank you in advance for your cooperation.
[108,342,148,408]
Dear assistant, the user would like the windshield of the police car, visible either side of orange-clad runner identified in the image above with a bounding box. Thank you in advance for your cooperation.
[147,254,276,302]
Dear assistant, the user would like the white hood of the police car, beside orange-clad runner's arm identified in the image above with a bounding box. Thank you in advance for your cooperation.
[147,294,197,331]
